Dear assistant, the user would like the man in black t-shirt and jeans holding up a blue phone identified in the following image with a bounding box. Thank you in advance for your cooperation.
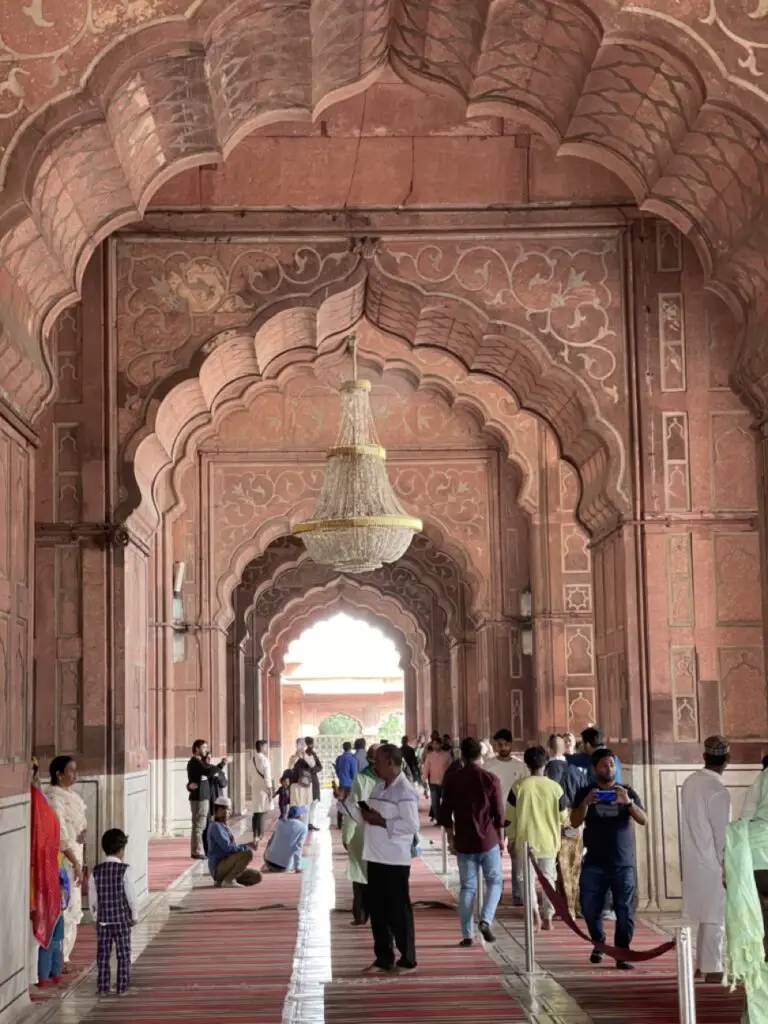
[570,748,648,971]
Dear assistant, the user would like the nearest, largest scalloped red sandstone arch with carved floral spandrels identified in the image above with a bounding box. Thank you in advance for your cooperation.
[7,0,768,416]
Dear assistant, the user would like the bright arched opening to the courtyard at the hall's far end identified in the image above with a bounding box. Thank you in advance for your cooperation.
[281,612,406,784]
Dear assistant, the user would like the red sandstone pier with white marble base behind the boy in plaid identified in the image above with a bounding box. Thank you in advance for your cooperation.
[34,253,151,896]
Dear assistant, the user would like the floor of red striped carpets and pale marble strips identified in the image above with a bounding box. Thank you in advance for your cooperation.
[15,826,740,1024]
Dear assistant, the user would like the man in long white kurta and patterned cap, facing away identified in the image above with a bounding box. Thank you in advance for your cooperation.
[680,736,731,983]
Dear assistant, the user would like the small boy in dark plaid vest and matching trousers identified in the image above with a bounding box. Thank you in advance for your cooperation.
[88,828,138,995]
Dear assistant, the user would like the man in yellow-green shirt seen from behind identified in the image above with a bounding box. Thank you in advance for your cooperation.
[507,746,568,932]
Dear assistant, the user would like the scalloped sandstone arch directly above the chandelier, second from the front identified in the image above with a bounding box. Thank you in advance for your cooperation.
[132,273,618,548]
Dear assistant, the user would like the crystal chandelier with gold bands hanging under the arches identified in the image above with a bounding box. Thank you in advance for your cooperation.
[295,338,422,572]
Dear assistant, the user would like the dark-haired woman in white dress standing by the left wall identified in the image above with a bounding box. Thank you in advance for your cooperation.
[45,755,88,973]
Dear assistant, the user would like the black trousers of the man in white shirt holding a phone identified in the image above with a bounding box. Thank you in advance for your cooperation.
[367,860,416,967]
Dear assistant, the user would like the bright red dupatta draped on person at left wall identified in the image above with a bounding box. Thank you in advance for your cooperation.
[30,785,61,948]
